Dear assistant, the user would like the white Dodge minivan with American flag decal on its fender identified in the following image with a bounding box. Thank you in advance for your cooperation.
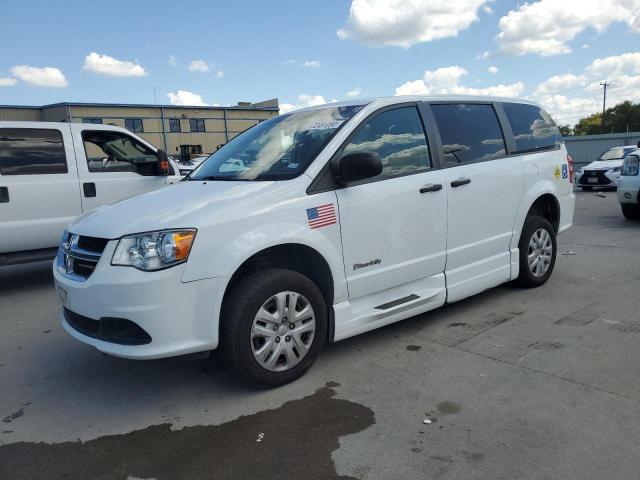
[54,96,575,386]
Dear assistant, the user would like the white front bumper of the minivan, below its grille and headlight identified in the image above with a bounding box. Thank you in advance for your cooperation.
[53,241,226,359]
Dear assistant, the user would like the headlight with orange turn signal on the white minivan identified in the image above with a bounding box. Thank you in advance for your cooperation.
[111,229,196,271]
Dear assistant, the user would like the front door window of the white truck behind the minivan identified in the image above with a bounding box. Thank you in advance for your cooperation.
[82,130,159,175]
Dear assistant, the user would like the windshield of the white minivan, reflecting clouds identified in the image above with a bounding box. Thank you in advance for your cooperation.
[188,105,363,180]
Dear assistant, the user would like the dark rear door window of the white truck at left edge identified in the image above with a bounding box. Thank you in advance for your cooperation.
[0,128,67,175]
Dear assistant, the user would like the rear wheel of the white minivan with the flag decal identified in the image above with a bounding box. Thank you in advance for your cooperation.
[516,215,557,288]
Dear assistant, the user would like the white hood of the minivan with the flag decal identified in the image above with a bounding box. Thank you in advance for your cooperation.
[69,181,297,239]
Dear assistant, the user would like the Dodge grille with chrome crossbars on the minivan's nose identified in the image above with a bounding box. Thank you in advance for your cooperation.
[56,233,109,282]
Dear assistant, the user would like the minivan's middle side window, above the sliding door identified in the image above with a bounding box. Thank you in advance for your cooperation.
[431,103,506,166]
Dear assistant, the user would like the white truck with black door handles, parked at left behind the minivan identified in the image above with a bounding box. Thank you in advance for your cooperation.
[0,122,180,266]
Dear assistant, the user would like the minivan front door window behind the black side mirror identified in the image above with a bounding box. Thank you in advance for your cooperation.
[343,107,430,179]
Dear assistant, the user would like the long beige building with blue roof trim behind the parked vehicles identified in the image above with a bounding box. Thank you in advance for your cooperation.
[0,99,279,158]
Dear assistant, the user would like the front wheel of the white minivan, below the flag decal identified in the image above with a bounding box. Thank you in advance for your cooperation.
[220,268,327,387]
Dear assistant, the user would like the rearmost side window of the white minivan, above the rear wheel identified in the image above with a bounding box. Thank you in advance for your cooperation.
[503,103,562,153]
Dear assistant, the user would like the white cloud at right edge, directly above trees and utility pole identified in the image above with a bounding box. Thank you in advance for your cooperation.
[533,52,640,124]
